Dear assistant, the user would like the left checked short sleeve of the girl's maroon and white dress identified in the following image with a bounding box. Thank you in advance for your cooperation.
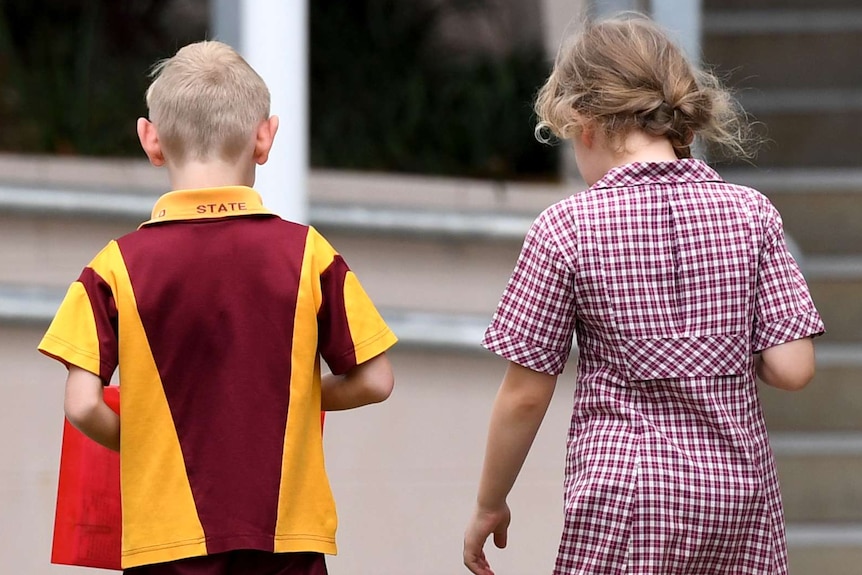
[482,211,575,375]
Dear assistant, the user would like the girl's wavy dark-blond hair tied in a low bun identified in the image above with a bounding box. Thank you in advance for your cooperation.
[535,13,757,162]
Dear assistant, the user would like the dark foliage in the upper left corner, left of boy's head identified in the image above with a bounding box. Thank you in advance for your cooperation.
[0,0,205,156]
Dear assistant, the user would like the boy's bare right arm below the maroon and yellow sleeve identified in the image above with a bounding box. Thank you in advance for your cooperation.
[320,353,395,411]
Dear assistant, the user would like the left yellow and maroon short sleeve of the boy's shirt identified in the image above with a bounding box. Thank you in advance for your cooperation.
[39,244,119,385]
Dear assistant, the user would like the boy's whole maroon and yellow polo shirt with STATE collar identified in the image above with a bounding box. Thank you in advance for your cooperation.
[39,187,396,567]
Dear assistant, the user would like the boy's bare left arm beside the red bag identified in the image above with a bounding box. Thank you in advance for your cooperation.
[64,365,120,451]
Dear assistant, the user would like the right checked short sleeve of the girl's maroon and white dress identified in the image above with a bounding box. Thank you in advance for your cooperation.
[752,204,824,353]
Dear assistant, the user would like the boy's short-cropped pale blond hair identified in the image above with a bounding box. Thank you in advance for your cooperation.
[147,41,269,163]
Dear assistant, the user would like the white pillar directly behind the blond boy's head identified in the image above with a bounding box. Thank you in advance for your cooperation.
[211,0,308,223]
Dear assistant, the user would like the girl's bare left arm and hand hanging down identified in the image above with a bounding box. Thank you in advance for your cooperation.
[464,362,557,575]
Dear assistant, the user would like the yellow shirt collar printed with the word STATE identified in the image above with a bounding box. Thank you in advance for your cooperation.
[140,186,275,227]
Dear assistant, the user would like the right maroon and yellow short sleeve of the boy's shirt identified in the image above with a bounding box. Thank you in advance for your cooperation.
[311,229,398,374]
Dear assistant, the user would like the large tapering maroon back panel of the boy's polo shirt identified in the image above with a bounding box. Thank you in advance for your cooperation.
[119,217,308,553]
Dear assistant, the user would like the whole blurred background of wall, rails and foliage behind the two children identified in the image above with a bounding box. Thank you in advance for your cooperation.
[0,0,862,575]
